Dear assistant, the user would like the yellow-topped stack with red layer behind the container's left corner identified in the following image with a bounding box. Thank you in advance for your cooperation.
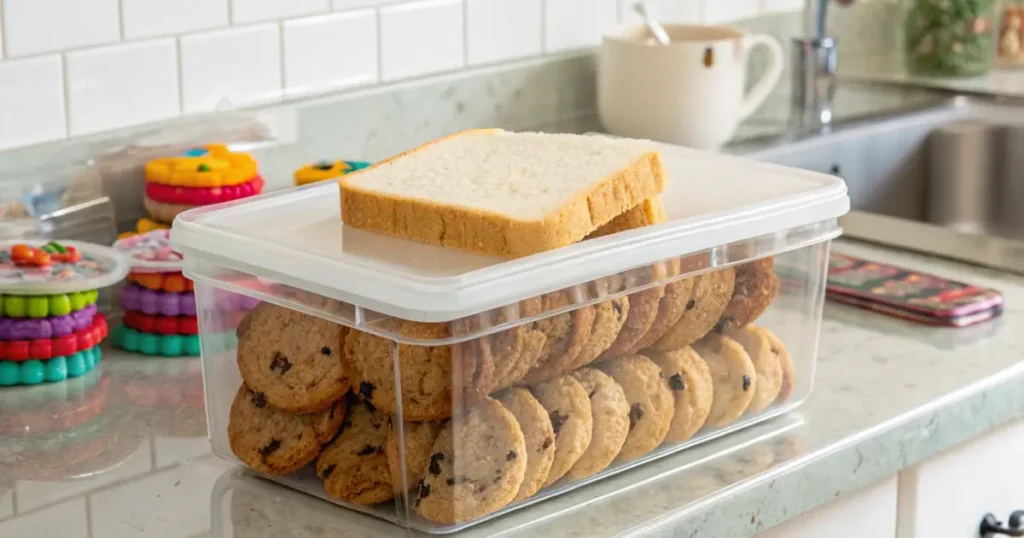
[139,143,263,226]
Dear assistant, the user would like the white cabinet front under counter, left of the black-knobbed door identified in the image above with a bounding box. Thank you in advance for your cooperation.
[759,475,896,538]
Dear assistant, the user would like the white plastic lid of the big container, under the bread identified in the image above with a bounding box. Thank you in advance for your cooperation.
[171,140,850,322]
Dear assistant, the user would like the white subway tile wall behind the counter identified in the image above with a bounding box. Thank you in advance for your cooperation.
[0,0,803,150]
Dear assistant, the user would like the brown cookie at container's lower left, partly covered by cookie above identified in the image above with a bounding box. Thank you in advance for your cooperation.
[227,385,345,474]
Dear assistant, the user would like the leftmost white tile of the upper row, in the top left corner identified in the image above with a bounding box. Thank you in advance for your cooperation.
[2,0,121,56]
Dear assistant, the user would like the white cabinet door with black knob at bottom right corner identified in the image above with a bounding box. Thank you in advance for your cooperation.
[898,421,1024,538]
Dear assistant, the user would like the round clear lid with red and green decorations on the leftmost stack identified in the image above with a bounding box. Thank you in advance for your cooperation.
[0,240,130,295]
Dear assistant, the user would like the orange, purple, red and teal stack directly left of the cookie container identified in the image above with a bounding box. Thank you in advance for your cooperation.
[114,230,200,357]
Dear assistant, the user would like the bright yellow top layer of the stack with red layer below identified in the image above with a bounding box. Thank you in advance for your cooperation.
[145,143,256,187]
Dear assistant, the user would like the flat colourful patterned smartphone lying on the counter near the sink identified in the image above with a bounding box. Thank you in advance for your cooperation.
[826,252,1004,327]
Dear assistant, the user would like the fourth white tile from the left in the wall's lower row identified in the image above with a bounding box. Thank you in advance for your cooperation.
[284,9,377,94]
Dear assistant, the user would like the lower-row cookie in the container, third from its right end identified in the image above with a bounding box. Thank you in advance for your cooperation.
[693,333,758,427]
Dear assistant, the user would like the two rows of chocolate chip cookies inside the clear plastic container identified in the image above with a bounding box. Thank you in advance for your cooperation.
[220,203,794,524]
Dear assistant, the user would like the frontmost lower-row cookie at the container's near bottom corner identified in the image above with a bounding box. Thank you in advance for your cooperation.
[413,397,527,525]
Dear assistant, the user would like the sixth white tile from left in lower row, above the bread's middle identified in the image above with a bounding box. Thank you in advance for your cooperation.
[466,0,544,65]
